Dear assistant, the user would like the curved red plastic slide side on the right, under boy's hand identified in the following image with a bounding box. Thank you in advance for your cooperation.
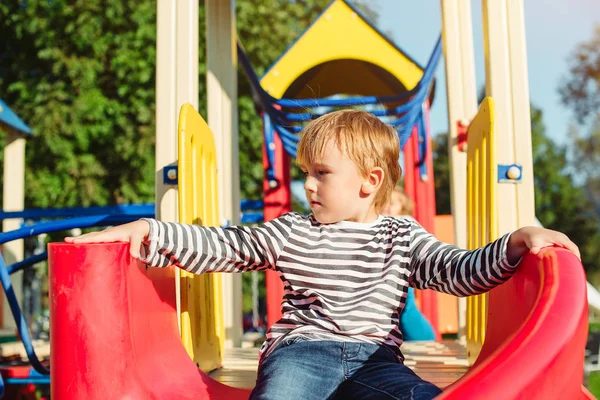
[439,249,593,400]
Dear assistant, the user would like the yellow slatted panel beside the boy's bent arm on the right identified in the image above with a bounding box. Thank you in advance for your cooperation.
[467,97,498,364]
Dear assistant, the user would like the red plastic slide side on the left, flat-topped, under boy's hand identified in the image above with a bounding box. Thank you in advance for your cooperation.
[49,243,250,400]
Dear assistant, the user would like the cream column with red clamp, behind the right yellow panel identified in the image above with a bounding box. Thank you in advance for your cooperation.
[441,0,477,338]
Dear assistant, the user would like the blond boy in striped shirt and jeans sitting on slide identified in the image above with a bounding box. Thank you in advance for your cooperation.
[66,110,578,399]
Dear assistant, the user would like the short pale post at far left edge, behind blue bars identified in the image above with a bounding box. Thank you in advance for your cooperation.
[2,132,25,331]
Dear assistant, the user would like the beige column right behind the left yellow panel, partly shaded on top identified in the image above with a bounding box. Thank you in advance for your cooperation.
[205,0,242,347]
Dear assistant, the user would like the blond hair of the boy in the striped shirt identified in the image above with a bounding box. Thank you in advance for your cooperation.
[296,110,402,212]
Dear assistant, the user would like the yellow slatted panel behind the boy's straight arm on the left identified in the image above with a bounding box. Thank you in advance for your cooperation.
[178,104,225,372]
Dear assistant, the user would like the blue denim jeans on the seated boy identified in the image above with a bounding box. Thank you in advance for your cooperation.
[250,338,442,400]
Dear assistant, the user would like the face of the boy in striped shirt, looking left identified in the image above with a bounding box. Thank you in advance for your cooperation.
[300,140,377,224]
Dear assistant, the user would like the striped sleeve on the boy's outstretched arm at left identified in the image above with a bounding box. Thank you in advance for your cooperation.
[141,214,292,274]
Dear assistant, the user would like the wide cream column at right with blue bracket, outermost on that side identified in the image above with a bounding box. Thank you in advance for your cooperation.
[482,0,535,235]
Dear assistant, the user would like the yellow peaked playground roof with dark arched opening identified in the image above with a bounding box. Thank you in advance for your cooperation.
[261,0,423,98]
